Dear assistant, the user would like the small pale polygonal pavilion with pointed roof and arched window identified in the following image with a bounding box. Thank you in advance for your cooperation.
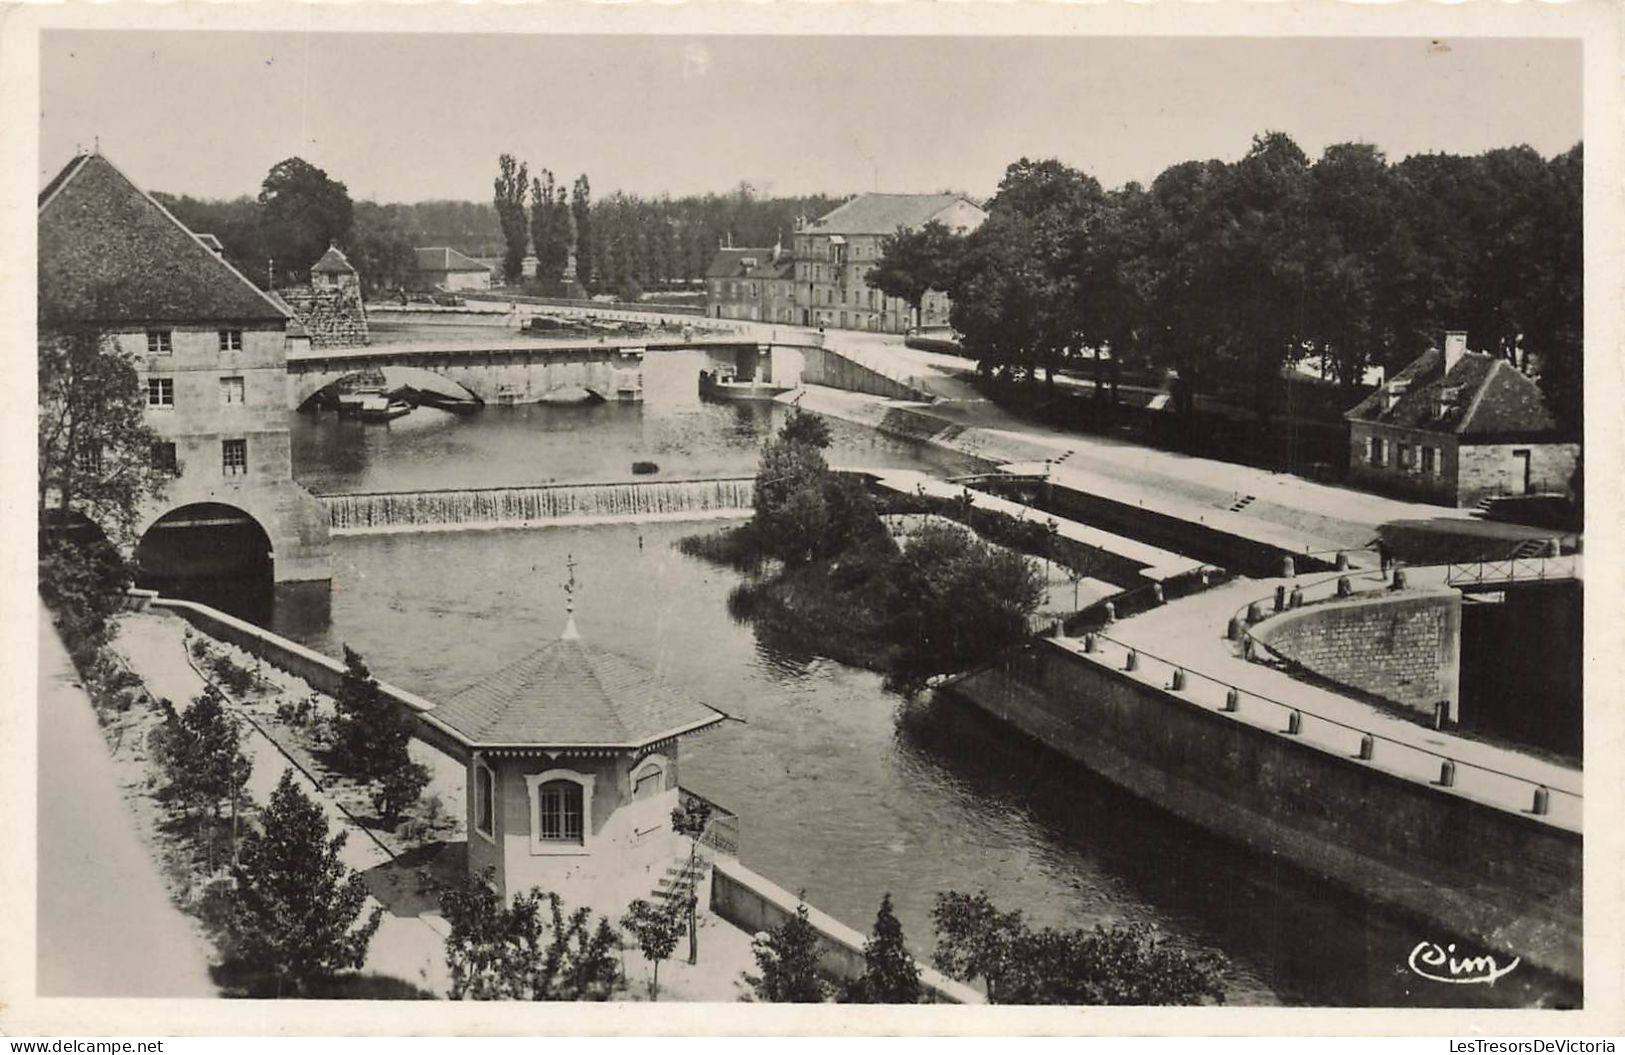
[423,591,726,909]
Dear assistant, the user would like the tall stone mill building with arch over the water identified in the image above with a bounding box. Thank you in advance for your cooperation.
[37,153,328,593]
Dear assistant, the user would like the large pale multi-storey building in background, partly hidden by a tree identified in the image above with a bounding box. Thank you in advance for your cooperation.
[793,193,988,333]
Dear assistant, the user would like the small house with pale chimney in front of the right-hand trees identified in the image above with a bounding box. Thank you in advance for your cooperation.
[1344,332,1580,507]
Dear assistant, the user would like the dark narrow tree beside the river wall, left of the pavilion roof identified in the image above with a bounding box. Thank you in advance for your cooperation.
[333,645,429,821]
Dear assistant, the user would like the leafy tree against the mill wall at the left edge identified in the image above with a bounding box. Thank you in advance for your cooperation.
[37,323,164,545]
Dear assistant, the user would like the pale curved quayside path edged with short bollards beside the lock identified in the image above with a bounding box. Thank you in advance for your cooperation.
[1055,569,1584,831]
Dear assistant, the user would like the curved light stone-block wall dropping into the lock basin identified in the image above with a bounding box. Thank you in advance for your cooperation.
[1251,587,1461,720]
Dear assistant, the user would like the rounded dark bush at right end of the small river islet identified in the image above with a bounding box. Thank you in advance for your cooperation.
[887,523,1043,689]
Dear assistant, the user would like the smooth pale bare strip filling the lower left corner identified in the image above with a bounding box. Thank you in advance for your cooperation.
[36,610,219,998]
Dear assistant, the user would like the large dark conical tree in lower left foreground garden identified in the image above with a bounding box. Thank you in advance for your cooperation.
[226,769,384,996]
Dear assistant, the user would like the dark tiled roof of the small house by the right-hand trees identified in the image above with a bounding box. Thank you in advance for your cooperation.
[1344,348,1557,439]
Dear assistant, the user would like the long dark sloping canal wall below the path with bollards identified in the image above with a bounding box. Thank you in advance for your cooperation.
[946,640,1584,980]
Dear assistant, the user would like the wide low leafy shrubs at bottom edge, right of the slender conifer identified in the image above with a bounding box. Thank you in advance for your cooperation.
[931,891,1227,1005]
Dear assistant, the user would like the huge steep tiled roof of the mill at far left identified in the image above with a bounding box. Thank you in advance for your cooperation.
[37,154,286,325]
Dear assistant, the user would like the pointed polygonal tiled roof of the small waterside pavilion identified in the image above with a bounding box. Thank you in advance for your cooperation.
[431,619,726,749]
